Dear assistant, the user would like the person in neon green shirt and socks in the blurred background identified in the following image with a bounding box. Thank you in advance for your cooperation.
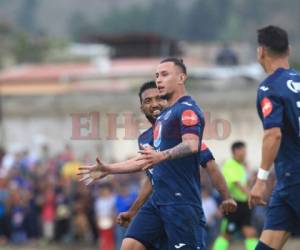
[213,141,257,250]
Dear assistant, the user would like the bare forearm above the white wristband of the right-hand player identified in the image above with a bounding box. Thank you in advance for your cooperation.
[261,128,281,171]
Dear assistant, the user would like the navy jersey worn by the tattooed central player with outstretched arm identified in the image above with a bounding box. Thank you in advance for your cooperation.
[152,96,204,207]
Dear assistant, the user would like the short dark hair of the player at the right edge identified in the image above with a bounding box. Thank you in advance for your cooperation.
[257,25,289,55]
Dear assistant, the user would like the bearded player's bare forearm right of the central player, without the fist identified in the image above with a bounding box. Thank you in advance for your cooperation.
[206,160,231,200]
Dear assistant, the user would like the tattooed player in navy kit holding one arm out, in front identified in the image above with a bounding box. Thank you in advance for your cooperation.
[77,58,232,250]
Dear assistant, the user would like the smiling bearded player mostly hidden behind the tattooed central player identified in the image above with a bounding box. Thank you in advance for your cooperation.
[117,82,236,249]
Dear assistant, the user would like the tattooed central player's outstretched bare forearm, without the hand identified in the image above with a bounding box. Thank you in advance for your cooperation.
[108,156,145,174]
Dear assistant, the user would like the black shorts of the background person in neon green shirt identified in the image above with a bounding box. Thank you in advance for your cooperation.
[220,201,252,234]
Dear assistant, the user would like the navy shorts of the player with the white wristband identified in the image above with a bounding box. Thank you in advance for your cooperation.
[264,185,300,233]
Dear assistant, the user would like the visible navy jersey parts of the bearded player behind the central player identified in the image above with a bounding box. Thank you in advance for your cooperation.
[138,127,215,184]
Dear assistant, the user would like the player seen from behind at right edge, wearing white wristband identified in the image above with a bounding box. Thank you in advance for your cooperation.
[249,26,300,250]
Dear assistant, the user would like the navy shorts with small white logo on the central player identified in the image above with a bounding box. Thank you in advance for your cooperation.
[125,199,206,250]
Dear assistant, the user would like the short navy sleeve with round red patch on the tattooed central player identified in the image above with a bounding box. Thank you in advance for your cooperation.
[180,106,204,135]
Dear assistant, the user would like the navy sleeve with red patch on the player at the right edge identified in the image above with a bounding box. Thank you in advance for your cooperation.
[257,89,284,129]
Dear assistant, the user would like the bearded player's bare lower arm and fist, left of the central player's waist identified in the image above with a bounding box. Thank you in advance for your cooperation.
[117,177,152,227]
